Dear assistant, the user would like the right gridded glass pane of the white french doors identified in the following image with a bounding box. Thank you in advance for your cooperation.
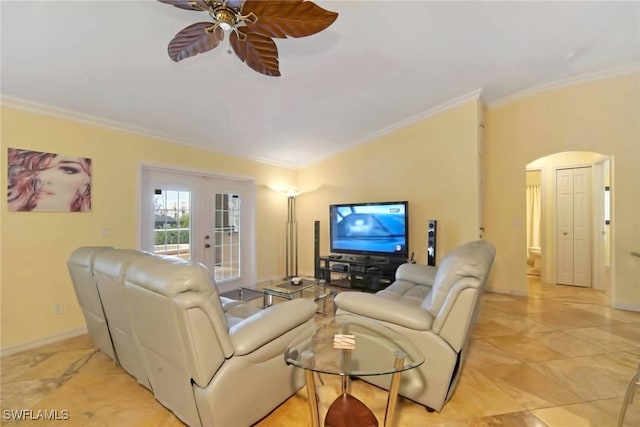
[214,193,241,282]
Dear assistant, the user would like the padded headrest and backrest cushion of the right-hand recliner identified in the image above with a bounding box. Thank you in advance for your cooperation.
[422,240,495,316]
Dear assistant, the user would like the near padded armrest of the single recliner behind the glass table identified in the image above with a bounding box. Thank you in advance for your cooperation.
[334,292,433,331]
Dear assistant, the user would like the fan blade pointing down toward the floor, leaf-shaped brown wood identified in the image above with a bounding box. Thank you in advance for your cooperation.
[229,27,280,77]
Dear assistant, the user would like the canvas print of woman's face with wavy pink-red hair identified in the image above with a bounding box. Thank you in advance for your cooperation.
[7,148,91,212]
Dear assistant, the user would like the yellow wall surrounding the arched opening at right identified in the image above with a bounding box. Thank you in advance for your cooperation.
[484,73,640,310]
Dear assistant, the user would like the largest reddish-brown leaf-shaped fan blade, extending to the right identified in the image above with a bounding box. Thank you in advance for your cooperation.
[242,0,338,38]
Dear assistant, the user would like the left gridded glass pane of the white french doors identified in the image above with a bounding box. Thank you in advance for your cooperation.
[153,189,191,259]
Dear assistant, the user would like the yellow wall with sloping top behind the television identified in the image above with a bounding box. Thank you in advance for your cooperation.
[297,99,480,274]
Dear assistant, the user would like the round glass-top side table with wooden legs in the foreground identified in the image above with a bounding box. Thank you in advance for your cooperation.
[285,314,424,427]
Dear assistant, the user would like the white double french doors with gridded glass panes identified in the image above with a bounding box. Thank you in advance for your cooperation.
[141,168,255,291]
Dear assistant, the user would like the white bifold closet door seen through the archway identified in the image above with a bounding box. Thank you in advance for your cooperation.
[556,168,592,287]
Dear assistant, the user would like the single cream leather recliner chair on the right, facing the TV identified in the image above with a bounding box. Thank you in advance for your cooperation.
[335,240,495,411]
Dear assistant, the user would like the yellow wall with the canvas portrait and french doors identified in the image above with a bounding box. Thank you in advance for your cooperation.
[0,106,297,349]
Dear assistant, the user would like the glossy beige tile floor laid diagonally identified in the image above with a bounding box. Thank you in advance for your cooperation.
[0,277,640,427]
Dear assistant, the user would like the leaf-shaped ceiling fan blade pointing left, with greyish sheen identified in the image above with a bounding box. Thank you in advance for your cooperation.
[167,22,224,62]
